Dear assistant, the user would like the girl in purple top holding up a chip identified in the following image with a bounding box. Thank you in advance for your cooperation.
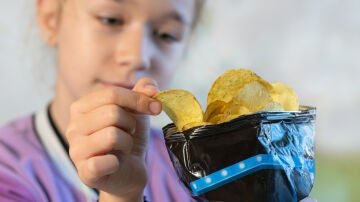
[0,0,203,202]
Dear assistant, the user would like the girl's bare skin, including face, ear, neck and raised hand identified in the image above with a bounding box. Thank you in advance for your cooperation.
[36,0,194,201]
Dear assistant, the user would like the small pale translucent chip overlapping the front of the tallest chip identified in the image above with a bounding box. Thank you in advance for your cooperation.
[234,81,273,112]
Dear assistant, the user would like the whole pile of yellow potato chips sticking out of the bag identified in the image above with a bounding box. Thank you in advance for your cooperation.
[154,69,299,131]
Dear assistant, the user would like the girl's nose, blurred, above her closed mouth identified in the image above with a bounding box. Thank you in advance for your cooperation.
[116,24,152,70]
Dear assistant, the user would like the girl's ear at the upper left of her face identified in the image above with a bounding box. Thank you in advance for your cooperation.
[36,0,60,47]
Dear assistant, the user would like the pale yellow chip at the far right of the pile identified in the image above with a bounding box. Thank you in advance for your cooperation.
[271,82,299,111]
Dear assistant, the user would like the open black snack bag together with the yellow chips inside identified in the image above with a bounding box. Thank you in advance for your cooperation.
[155,69,316,202]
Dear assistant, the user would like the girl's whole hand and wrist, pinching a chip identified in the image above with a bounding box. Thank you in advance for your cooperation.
[66,79,161,201]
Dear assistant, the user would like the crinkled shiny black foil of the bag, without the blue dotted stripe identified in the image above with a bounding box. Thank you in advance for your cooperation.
[163,106,316,202]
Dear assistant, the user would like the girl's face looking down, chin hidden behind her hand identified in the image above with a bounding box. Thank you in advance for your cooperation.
[56,0,195,99]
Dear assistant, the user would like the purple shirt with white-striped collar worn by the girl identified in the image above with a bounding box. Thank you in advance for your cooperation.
[0,110,194,202]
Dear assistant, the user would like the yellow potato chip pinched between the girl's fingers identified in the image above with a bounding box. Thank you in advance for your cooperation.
[154,89,203,131]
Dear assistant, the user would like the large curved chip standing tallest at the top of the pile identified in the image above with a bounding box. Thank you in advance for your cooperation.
[207,69,272,105]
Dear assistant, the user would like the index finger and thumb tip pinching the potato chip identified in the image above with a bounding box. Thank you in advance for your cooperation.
[71,79,161,115]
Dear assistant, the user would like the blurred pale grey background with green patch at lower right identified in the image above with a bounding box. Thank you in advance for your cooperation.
[0,0,360,202]
